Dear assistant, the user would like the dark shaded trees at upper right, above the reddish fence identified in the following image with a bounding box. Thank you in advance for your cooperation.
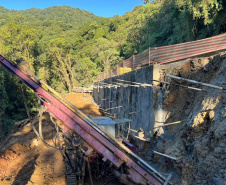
[138,0,226,51]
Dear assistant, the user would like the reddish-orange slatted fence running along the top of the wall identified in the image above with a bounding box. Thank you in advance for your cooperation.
[97,33,226,81]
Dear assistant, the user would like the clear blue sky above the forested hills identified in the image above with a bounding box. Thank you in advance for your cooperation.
[0,0,144,17]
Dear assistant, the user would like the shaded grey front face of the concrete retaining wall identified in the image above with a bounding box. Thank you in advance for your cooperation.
[93,66,155,133]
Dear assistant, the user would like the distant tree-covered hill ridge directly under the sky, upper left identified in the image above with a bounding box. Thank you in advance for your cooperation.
[0,6,100,28]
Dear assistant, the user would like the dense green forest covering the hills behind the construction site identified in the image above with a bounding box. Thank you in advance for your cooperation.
[0,0,226,139]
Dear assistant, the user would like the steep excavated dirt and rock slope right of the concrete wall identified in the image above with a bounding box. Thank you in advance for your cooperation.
[152,53,226,185]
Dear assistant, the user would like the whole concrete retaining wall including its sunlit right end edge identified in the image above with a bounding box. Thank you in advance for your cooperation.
[93,59,190,135]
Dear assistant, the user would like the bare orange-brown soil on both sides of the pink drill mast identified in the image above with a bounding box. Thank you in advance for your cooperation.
[0,94,101,185]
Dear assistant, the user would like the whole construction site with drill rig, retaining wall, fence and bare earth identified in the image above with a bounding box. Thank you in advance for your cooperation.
[0,31,226,185]
